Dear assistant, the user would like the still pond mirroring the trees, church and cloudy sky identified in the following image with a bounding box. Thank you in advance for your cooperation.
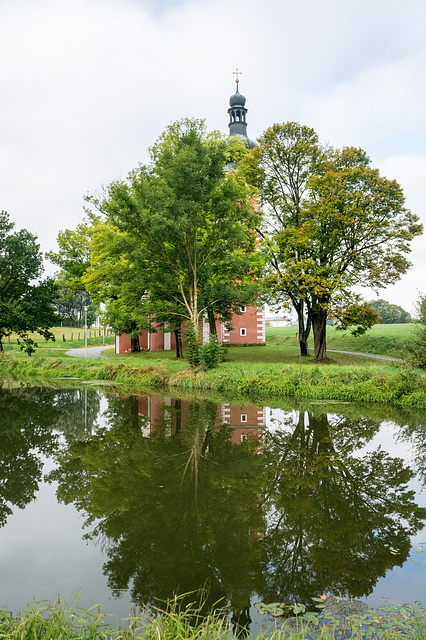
[0,386,426,631]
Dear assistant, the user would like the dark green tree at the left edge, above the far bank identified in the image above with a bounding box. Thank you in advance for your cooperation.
[0,211,56,355]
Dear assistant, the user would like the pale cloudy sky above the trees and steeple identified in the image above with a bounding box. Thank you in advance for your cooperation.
[0,0,426,312]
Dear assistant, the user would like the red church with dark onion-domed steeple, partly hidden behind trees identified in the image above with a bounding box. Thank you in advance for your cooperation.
[115,77,265,353]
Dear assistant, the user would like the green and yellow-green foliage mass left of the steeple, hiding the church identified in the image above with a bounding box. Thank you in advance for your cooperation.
[84,119,261,348]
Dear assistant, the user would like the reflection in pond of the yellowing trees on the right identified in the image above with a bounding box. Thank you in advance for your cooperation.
[263,412,426,602]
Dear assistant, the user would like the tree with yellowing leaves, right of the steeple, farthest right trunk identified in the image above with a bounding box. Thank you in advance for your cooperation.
[304,147,423,360]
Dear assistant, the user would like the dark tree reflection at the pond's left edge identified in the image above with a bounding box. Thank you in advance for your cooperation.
[0,388,60,526]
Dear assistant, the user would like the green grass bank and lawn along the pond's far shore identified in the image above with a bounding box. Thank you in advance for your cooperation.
[0,325,426,409]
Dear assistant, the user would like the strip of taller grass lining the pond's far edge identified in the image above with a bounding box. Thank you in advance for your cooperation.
[0,347,426,409]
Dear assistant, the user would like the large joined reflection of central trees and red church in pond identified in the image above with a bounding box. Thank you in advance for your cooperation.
[44,396,426,625]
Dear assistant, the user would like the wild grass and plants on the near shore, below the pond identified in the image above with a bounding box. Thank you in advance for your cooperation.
[0,598,426,640]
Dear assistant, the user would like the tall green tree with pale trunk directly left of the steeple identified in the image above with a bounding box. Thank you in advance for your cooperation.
[85,119,261,360]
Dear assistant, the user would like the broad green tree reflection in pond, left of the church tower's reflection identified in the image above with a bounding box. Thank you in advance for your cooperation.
[47,398,263,611]
